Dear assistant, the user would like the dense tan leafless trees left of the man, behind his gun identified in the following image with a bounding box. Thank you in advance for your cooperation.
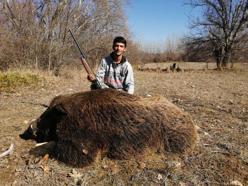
[0,0,132,70]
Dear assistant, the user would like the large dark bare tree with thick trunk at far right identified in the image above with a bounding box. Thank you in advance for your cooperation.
[190,0,248,69]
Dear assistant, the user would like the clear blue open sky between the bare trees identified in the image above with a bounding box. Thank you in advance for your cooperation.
[126,0,199,50]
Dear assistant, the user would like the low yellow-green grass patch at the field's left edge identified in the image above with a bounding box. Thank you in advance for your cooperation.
[0,72,41,92]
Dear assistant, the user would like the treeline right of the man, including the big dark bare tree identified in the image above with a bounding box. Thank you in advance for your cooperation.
[141,0,248,69]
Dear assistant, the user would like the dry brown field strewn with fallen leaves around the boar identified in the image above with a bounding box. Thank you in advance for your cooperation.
[0,66,248,186]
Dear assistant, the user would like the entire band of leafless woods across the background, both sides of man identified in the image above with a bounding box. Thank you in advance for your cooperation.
[0,0,248,71]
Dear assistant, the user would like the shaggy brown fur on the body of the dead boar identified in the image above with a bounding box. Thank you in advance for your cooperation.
[20,89,196,166]
